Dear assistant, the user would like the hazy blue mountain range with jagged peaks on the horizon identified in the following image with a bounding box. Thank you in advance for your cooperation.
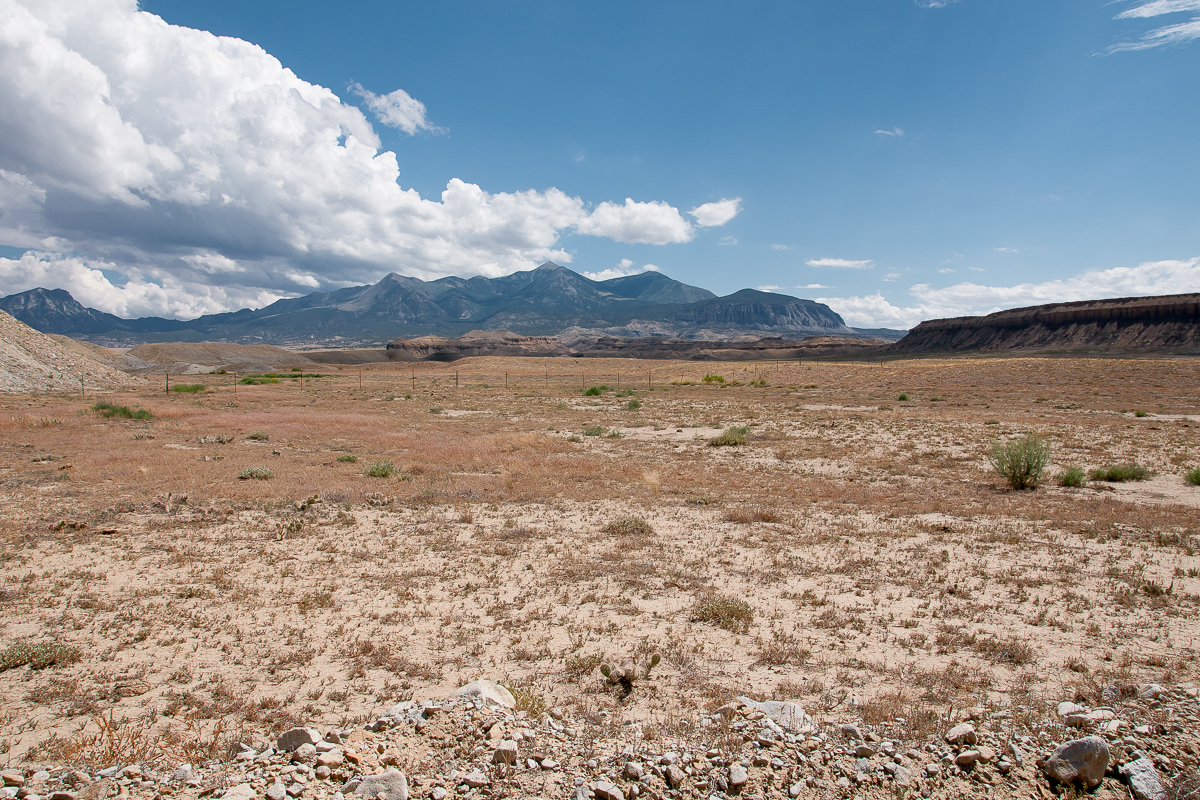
[0,261,902,348]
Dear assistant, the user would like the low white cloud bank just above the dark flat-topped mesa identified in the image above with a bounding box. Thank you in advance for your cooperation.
[817,258,1200,327]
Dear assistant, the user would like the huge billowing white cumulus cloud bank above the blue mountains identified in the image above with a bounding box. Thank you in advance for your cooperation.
[0,0,738,317]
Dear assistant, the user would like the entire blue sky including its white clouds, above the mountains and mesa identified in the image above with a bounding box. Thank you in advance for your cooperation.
[0,0,1200,327]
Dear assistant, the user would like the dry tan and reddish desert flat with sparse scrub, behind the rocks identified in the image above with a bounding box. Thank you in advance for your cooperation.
[0,359,1200,796]
